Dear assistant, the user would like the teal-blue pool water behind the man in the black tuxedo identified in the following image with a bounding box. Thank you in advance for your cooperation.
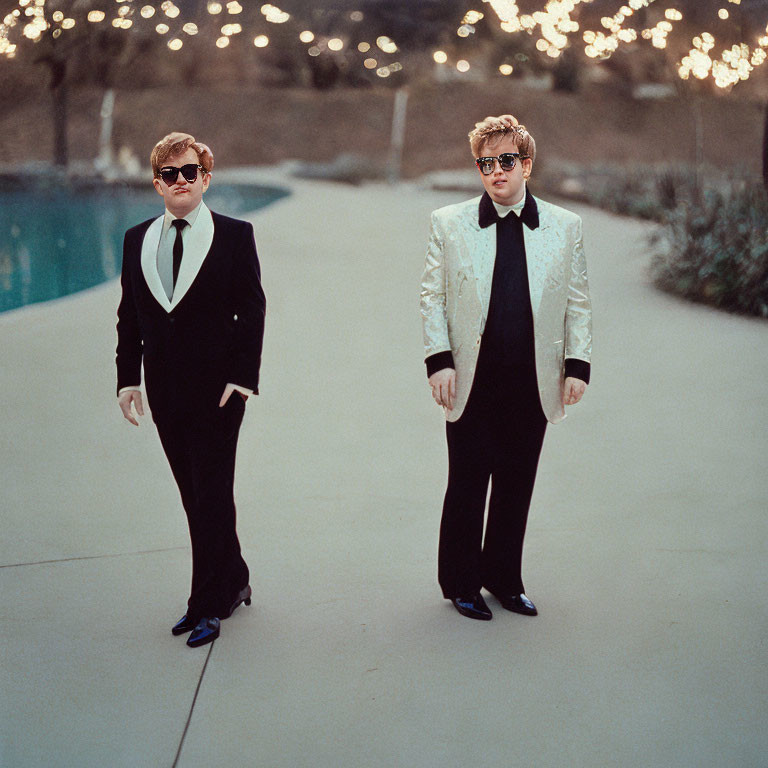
[0,182,288,312]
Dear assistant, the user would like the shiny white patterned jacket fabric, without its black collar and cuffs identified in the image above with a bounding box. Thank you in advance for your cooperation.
[421,191,592,424]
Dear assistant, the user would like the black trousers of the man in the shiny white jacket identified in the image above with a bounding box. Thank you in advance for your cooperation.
[438,349,547,599]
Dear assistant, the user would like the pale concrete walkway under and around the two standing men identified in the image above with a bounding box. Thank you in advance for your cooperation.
[0,176,768,768]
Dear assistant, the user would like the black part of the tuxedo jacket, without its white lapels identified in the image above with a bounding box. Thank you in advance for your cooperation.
[117,212,266,416]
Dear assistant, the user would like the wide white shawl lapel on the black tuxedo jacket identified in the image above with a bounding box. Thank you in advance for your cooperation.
[141,203,214,312]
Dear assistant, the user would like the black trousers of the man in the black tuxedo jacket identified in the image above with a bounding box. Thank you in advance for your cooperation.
[153,392,249,618]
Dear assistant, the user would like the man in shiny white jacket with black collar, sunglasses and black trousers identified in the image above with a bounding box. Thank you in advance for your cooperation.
[421,115,592,620]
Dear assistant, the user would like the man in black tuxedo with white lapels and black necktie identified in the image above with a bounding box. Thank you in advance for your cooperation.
[117,133,265,647]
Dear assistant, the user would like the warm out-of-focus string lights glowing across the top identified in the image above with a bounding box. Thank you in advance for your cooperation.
[0,0,768,88]
